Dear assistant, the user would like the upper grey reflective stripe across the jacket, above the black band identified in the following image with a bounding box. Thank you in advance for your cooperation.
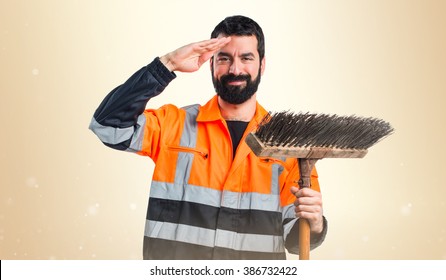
[150,181,281,212]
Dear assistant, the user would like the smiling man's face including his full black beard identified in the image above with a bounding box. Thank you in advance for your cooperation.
[211,35,265,104]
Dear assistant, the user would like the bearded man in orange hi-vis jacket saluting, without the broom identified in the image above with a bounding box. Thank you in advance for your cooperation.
[90,16,327,259]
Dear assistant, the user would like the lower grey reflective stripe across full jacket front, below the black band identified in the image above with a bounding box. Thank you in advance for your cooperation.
[144,220,284,253]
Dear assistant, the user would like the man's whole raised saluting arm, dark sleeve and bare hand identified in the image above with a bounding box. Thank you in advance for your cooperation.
[89,37,231,152]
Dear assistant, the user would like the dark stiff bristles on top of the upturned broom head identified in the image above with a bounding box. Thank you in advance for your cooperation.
[255,111,394,149]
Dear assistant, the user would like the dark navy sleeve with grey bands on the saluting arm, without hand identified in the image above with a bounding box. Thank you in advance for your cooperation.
[89,58,176,152]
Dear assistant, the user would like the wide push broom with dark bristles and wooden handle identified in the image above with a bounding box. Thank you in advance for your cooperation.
[246,111,393,260]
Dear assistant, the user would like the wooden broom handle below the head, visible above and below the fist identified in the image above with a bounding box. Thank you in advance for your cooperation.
[298,158,317,260]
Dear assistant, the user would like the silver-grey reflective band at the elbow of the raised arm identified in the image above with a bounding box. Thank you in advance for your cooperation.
[89,118,133,145]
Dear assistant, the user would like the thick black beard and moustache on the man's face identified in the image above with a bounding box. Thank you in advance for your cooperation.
[212,69,261,105]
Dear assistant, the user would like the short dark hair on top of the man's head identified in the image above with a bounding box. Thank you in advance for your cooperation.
[211,16,265,61]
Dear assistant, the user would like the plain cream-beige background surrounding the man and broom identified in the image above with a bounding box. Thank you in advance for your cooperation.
[0,0,446,259]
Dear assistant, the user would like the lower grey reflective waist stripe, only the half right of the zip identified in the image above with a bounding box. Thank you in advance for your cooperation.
[215,229,284,253]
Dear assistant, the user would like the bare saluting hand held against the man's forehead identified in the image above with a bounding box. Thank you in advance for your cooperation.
[160,37,231,72]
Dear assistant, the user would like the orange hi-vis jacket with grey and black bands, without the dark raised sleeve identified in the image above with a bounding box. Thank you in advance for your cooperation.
[129,96,319,259]
